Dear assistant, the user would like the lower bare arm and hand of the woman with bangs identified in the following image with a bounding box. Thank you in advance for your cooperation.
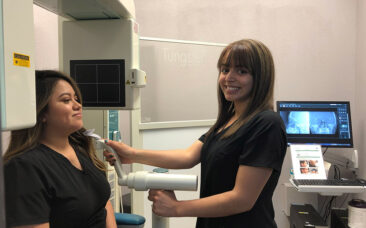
[149,165,272,218]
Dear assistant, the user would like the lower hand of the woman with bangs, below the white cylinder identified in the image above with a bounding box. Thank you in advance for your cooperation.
[148,189,179,217]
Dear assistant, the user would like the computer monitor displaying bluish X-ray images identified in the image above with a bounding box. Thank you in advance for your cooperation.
[277,101,353,148]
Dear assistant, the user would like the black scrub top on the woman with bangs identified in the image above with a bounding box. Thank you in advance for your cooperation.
[196,110,287,228]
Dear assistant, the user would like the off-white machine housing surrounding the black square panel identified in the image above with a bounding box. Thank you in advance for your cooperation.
[60,18,146,110]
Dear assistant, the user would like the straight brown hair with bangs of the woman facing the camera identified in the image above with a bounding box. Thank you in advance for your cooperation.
[206,39,275,138]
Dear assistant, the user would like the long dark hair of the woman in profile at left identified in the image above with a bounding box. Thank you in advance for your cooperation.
[3,70,106,171]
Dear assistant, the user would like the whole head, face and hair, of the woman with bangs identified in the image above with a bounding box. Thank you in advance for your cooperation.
[217,39,274,119]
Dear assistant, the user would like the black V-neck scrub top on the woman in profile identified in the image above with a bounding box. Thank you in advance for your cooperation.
[4,145,110,228]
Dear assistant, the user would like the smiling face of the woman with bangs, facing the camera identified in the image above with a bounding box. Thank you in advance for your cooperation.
[219,64,253,104]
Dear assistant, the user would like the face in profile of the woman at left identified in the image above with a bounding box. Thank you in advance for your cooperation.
[42,80,83,135]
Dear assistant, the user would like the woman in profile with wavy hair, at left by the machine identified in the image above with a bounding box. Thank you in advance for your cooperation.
[3,70,117,228]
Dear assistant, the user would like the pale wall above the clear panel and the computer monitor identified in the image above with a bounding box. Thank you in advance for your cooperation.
[135,0,357,105]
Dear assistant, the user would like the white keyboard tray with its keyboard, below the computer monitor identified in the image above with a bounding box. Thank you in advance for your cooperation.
[290,179,366,195]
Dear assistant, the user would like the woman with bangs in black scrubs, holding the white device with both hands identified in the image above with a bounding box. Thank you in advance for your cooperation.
[104,39,287,228]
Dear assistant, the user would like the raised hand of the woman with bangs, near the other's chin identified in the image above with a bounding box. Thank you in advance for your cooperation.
[103,140,135,165]
